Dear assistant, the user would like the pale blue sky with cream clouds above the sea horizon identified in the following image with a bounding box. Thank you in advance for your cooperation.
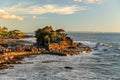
[0,0,120,32]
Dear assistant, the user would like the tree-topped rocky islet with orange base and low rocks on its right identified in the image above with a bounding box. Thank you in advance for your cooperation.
[36,26,91,55]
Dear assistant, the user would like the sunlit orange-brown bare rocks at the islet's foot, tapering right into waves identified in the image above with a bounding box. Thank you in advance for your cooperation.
[47,41,92,56]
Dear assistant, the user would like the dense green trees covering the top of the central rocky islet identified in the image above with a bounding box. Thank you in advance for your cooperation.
[35,26,65,45]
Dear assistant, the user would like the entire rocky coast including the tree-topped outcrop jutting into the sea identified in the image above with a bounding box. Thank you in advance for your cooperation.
[0,26,92,69]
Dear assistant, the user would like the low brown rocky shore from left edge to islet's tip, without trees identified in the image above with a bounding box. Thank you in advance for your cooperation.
[0,39,91,69]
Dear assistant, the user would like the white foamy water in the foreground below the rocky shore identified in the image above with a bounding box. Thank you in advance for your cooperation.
[0,49,119,80]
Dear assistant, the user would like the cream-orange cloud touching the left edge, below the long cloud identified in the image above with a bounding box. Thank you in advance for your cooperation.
[0,9,23,21]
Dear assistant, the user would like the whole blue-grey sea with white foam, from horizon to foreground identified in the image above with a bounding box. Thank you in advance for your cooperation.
[0,32,120,80]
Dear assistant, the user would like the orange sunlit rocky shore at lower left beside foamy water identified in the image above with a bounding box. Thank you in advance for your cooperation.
[0,52,40,69]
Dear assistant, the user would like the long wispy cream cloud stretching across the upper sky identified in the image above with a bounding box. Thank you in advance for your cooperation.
[4,4,85,15]
